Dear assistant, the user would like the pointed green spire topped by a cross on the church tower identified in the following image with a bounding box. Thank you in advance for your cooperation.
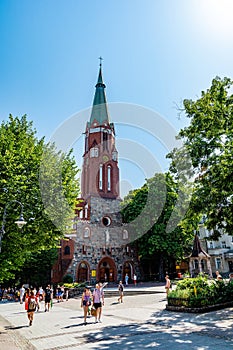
[90,57,109,125]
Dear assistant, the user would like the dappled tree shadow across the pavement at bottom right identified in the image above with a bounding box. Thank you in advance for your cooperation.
[71,310,233,350]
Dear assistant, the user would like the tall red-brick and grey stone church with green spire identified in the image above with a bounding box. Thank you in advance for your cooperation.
[51,59,140,283]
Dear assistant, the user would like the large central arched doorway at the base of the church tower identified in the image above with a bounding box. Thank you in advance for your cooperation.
[97,257,117,282]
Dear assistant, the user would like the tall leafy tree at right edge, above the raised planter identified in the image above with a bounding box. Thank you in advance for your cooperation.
[169,77,233,238]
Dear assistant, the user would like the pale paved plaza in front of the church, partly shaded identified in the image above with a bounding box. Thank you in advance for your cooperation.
[0,286,233,350]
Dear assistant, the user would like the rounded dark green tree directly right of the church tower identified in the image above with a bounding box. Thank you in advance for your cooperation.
[122,173,193,278]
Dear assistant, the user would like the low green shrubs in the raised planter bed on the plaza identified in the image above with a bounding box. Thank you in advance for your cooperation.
[168,275,233,307]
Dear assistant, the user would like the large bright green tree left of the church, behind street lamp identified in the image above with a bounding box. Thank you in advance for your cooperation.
[0,115,79,281]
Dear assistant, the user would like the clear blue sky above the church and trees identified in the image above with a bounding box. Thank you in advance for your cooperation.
[0,0,233,197]
